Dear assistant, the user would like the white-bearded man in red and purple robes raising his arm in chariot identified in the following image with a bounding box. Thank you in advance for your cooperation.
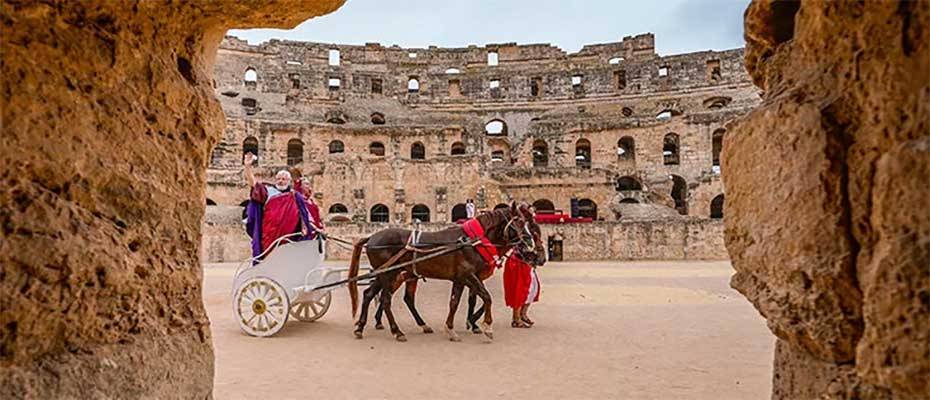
[243,153,313,257]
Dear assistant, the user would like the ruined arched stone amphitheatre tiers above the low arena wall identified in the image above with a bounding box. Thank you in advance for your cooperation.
[207,34,759,234]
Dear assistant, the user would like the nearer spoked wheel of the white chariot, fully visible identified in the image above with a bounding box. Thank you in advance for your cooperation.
[233,278,290,337]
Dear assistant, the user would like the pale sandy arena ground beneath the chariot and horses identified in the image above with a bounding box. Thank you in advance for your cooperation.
[204,261,774,400]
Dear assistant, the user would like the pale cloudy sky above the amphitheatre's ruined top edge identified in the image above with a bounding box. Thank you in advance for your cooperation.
[229,0,749,55]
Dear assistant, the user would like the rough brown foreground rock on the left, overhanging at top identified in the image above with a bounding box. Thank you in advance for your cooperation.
[0,0,342,399]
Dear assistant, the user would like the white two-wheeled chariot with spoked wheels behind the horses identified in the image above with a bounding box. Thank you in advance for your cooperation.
[232,234,347,337]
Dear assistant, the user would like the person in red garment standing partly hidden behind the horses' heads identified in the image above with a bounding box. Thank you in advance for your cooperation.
[504,254,539,328]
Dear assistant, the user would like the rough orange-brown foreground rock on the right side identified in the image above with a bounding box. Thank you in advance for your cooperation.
[723,0,930,399]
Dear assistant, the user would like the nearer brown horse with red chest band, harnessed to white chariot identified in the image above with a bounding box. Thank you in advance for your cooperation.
[348,203,545,341]
